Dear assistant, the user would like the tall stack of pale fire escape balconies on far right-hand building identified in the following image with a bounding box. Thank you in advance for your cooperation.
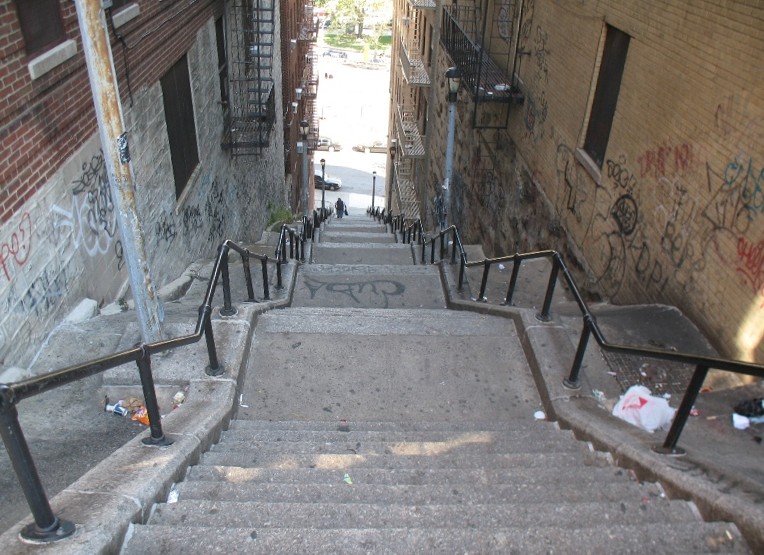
[393,0,436,224]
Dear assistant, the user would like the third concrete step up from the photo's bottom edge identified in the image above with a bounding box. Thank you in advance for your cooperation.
[175,478,665,506]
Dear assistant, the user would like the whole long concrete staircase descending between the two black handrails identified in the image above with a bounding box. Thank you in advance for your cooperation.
[123,216,748,555]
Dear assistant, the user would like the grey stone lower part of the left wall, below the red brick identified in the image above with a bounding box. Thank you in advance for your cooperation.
[0,14,287,368]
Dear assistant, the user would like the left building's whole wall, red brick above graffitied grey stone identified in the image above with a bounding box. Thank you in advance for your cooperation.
[0,0,287,368]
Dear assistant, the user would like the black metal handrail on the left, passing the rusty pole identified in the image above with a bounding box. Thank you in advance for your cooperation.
[0,238,294,543]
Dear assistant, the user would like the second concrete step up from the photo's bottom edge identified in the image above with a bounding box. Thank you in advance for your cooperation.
[148,498,702,531]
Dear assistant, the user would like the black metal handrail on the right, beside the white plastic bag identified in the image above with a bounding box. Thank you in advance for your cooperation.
[430,226,764,455]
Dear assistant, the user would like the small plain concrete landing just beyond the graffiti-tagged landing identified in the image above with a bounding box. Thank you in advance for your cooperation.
[311,241,416,266]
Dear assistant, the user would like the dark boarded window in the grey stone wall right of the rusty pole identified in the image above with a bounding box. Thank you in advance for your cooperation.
[161,54,199,198]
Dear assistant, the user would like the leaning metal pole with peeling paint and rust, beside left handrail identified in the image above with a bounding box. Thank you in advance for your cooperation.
[75,0,164,343]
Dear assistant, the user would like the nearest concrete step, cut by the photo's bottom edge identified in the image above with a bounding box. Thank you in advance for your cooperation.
[122,522,748,555]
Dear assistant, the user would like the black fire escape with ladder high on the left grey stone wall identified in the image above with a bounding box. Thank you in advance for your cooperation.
[222,0,276,156]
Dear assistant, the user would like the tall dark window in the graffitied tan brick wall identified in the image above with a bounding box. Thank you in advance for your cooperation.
[584,25,630,168]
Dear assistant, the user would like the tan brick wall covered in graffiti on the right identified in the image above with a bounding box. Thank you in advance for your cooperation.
[431,0,764,361]
